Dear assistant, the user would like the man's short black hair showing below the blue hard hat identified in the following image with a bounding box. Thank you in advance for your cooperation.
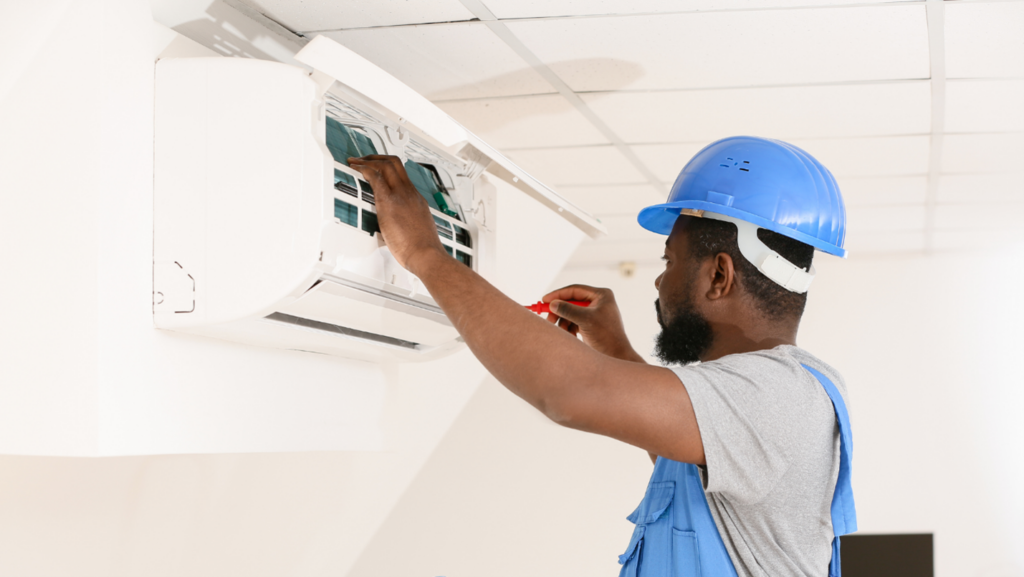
[686,217,814,320]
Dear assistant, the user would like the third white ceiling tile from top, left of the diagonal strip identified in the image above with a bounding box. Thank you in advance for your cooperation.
[437,94,609,149]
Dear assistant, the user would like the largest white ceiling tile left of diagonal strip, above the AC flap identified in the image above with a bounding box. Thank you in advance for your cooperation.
[326,23,554,99]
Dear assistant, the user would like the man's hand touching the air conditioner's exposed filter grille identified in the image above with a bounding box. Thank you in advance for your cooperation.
[348,155,446,276]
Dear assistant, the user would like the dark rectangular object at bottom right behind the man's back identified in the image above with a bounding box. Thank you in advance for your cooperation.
[840,533,935,577]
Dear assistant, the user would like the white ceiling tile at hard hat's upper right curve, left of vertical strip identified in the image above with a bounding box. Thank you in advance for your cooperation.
[791,136,929,178]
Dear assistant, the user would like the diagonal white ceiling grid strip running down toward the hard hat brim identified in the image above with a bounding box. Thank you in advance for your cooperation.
[460,0,668,194]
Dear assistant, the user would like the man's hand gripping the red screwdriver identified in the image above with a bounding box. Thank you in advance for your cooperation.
[541,285,646,363]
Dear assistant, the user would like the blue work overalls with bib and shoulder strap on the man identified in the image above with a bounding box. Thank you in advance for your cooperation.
[618,365,857,577]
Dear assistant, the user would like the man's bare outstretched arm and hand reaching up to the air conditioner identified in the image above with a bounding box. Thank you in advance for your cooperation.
[349,156,703,464]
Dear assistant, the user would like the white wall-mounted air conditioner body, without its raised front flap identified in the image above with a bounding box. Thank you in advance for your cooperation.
[154,57,496,362]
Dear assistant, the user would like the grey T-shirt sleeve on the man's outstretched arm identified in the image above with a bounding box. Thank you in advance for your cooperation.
[674,359,795,504]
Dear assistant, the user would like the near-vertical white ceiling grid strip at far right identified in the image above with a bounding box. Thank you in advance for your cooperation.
[925,0,946,252]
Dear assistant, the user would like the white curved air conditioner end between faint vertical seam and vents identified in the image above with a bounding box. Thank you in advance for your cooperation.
[207,58,329,320]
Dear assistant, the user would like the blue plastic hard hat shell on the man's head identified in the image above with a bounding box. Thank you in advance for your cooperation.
[637,136,846,257]
